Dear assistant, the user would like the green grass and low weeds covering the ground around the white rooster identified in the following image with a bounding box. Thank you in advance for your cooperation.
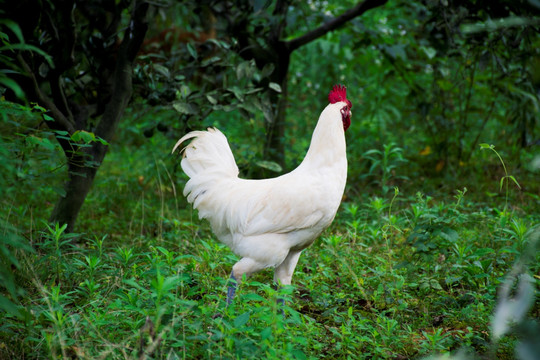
[0,128,540,359]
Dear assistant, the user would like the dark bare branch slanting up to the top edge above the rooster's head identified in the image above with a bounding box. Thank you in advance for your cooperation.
[286,0,388,52]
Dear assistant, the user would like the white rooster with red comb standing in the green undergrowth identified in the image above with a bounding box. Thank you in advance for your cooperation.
[173,85,352,304]
